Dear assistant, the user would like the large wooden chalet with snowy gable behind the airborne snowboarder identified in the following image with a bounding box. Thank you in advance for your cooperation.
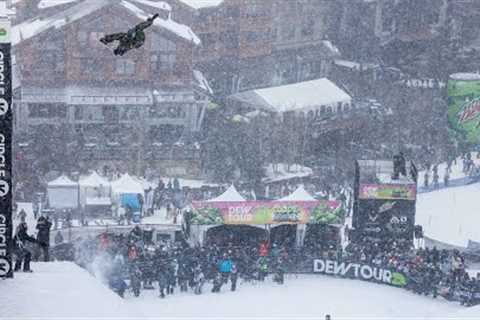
[12,0,211,176]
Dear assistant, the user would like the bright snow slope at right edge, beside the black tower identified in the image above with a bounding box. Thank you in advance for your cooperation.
[416,183,480,247]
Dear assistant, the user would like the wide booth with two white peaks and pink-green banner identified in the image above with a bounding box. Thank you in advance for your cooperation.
[191,186,343,246]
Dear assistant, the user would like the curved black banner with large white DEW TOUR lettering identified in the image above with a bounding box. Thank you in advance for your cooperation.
[313,259,408,287]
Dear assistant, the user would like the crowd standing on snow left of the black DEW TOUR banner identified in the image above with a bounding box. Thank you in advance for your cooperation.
[76,226,285,298]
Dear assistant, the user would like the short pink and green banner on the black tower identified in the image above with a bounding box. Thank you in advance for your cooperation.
[358,184,417,201]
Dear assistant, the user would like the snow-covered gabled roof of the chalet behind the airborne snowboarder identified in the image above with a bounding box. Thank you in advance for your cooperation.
[12,0,200,45]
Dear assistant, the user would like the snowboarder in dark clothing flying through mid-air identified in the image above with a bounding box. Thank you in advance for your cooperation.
[100,13,158,56]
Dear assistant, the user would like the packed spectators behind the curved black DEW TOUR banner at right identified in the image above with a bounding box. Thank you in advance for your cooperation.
[343,240,480,305]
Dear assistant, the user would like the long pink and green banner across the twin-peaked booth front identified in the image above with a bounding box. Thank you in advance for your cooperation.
[192,201,343,225]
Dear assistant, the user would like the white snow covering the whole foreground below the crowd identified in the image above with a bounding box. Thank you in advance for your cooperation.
[0,262,464,319]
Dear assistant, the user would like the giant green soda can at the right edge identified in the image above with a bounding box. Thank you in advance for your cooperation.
[448,73,480,145]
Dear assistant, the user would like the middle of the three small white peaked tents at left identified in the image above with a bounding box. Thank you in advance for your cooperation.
[78,171,112,207]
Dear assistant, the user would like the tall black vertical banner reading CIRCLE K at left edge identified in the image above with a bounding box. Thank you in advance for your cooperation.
[0,17,13,278]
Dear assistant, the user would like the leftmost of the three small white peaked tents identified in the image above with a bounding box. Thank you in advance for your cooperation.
[47,175,78,209]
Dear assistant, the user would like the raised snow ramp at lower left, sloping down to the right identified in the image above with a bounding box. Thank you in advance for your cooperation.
[0,262,139,319]
